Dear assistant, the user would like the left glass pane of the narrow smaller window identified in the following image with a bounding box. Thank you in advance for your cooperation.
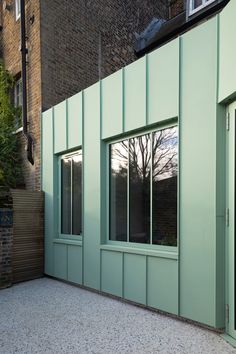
[61,158,71,234]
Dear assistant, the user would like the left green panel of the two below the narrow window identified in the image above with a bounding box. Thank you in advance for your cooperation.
[54,243,67,280]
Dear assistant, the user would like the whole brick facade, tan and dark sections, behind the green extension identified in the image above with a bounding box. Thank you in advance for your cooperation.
[0,0,182,189]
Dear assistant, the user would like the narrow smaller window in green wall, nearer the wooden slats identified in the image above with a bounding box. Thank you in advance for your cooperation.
[60,150,82,235]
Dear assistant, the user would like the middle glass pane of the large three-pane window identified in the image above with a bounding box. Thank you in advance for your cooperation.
[129,134,151,243]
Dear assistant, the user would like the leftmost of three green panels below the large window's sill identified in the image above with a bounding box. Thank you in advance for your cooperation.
[101,251,123,297]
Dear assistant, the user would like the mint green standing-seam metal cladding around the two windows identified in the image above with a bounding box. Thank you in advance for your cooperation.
[42,0,236,328]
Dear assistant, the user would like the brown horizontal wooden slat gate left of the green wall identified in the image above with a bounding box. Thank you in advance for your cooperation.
[11,189,44,283]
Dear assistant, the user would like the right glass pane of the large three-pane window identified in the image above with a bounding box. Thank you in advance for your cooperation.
[152,127,178,246]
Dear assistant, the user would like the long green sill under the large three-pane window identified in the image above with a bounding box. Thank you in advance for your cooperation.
[100,244,179,260]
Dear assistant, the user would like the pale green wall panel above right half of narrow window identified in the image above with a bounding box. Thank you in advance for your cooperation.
[67,92,83,149]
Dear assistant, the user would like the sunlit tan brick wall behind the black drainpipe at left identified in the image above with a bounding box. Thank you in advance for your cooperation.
[0,0,41,189]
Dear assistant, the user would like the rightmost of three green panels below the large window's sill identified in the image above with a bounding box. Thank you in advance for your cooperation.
[147,257,178,314]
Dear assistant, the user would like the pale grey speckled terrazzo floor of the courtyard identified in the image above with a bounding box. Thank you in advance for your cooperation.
[0,278,236,354]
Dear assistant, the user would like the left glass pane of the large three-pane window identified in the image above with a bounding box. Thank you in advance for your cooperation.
[110,140,128,241]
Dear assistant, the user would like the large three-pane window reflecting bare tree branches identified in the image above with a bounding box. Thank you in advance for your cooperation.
[109,126,178,246]
